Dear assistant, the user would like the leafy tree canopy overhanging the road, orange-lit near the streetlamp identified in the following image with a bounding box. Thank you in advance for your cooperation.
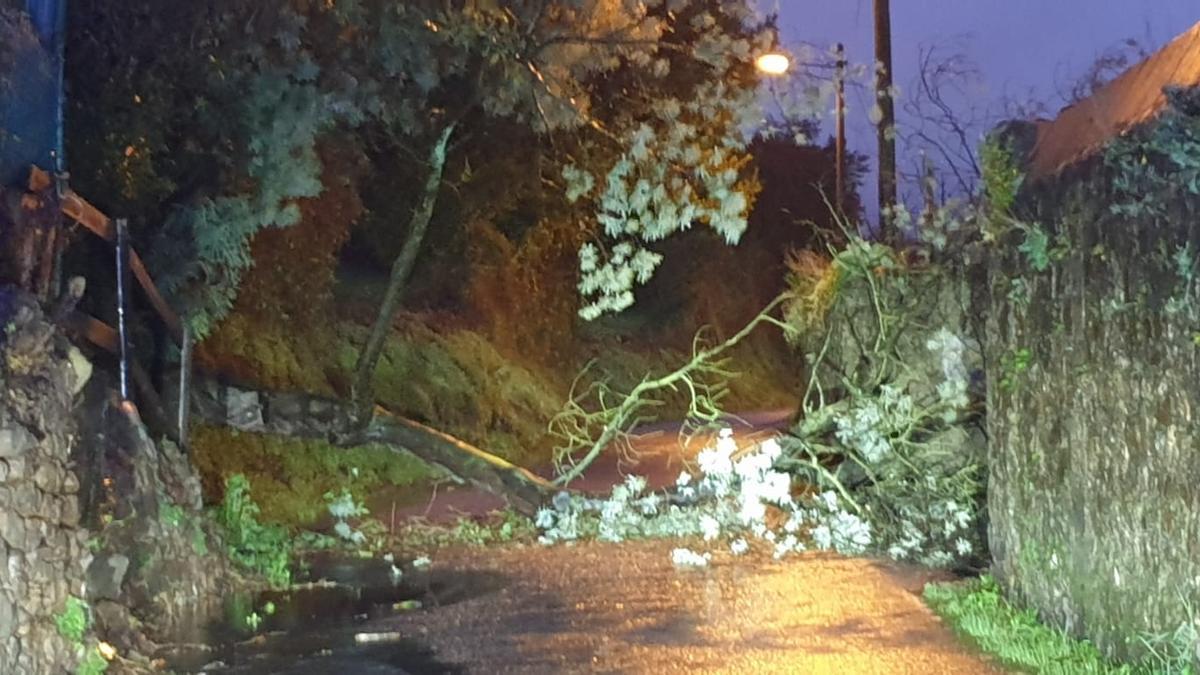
[71,0,772,333]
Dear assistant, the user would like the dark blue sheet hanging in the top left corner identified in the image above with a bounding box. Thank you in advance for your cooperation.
[0,0,66,185]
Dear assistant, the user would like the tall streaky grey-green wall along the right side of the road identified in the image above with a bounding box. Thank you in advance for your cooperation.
[985,149,1200,659]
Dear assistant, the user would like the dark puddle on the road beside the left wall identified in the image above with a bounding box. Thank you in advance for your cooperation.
[160,557,505,675]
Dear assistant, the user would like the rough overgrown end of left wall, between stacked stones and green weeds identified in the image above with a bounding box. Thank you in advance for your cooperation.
[76,374,232,661]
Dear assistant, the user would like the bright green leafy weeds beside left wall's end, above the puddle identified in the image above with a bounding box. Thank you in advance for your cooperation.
[216,473,292,587]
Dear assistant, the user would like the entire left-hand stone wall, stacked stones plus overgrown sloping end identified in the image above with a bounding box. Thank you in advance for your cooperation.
[0,286,233,675]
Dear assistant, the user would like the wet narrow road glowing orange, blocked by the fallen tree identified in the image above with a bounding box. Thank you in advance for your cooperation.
[338,411,1000,675]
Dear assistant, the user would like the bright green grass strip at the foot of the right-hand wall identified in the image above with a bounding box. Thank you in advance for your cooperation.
[924,577,1194,675]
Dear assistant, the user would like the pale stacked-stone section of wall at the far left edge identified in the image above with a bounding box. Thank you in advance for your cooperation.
[0,288,91,675]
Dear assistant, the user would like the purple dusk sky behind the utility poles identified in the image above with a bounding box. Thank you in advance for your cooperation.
[762,0,1200,220]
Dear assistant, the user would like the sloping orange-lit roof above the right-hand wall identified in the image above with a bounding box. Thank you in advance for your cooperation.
[1028,23,1200,179]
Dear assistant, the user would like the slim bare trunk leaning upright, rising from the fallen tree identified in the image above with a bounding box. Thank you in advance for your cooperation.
[350,123,455,429]
